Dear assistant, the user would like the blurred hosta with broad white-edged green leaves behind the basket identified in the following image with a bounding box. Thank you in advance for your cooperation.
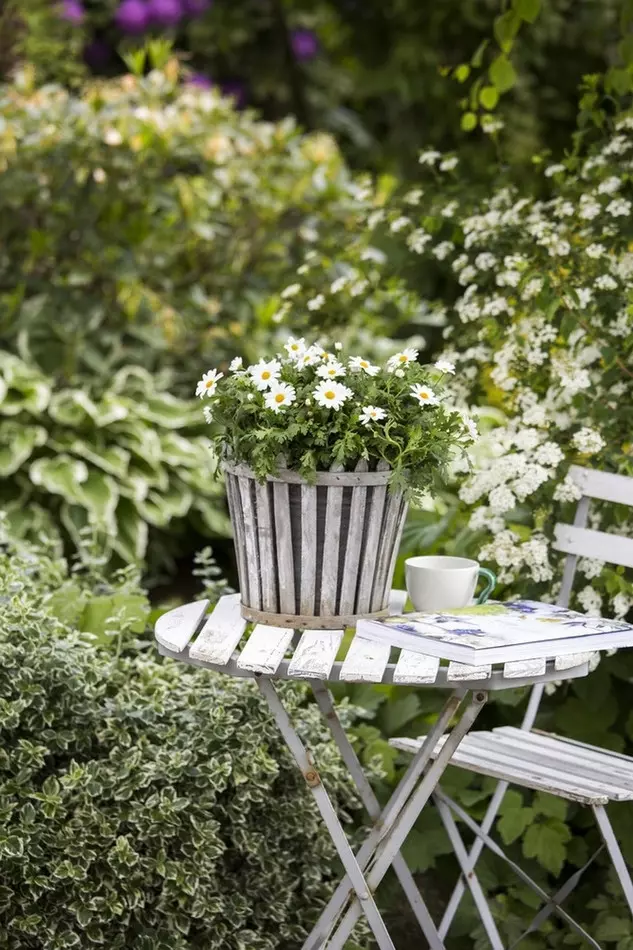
[0,353,230,562]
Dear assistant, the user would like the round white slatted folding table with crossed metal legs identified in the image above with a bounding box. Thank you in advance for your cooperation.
[155,591,591,950]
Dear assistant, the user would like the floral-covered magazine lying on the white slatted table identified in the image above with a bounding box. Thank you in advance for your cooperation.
[356,600,633,666]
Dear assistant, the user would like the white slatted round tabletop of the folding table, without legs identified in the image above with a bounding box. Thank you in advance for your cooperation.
[155,591,592,690]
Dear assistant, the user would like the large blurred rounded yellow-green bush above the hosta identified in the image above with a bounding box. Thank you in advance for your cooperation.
[0,62,410,395]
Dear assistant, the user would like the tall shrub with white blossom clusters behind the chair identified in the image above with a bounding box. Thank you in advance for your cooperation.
[392,122,633,617]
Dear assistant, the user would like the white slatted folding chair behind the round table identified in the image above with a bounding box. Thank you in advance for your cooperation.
[392,466,633,950]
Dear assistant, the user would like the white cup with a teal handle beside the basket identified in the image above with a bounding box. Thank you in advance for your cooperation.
[404,555,497,611]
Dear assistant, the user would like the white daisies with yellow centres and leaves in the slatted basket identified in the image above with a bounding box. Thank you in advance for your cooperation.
[196,336,476,491]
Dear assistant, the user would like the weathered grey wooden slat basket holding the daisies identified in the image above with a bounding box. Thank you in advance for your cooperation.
[225,462,407,629]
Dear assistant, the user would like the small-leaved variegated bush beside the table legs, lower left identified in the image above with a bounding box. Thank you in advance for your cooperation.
[0,548,366,950]
